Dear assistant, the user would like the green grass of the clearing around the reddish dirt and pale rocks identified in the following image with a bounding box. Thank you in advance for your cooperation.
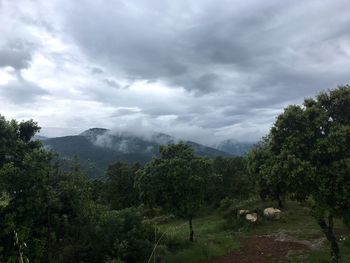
[155,201,350,263]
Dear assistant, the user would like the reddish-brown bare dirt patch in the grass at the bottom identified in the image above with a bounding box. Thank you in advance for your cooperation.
[206,236,310,263]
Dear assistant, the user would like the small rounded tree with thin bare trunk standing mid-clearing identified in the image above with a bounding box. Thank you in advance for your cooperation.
[136,143,212,241]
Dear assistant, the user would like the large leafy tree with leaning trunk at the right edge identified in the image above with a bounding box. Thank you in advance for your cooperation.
[252,86,350,262]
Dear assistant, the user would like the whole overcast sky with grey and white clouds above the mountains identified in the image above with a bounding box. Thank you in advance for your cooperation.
[0,0,350,145]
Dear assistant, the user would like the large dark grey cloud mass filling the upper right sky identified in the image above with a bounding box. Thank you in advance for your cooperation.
[60,1,350,96]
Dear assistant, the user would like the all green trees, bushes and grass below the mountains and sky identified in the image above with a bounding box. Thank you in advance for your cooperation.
[0,86,350,263]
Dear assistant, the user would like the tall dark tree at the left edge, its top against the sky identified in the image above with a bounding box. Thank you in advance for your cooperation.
[0,116,51,261]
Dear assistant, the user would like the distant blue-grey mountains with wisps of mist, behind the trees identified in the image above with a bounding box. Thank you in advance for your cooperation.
[42,128,231,177]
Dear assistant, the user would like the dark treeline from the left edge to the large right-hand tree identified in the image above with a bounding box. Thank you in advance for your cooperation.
[0,116,250,262]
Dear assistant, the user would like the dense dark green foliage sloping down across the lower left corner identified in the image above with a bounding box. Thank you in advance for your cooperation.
[0,116,152,262]
